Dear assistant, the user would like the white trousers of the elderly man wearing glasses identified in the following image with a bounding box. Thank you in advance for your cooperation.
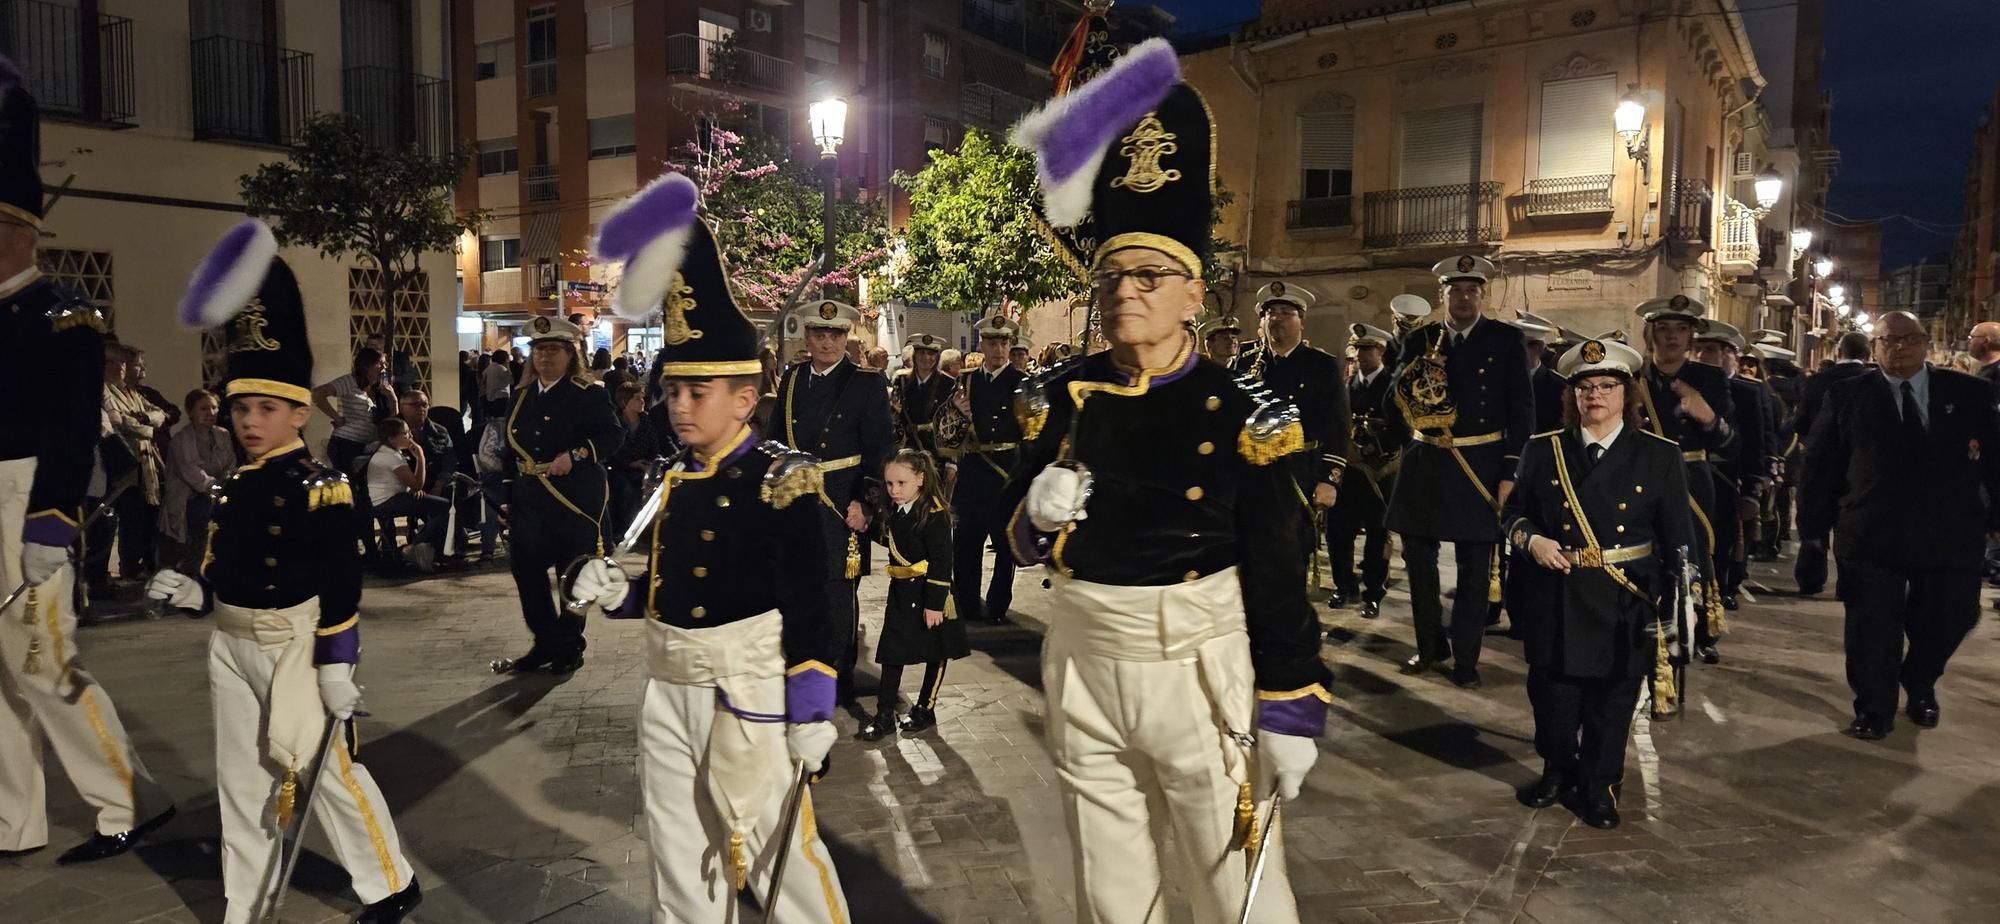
[1042,568,1298,924]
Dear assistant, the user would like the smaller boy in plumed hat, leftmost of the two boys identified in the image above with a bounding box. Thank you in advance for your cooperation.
[146,220,422,924]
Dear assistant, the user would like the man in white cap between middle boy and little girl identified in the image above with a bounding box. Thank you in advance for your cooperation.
[770,300,896,702]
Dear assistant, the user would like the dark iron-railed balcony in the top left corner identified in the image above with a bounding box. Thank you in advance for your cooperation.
[0,0,136,128]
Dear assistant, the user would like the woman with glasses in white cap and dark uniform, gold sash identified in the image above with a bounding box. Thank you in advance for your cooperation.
[1500,340,1694,828]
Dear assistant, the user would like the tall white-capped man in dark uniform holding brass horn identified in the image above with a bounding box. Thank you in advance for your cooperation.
[1388,254,1534,688]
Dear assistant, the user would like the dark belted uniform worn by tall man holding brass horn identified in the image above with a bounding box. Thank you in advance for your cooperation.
[1388,318,1534,670]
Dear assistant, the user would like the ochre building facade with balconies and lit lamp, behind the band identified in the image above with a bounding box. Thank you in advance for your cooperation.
[1184,0,1798,344]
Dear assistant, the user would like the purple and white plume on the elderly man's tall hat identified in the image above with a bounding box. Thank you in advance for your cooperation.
[1008,38,1180,228]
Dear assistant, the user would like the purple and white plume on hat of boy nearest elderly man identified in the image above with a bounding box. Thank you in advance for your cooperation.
[590,172,702,320]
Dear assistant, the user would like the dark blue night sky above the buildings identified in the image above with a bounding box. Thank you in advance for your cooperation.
[1156,0,2000,270]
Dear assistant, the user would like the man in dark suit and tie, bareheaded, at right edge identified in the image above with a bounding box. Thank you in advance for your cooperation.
[1798,312,2000,740]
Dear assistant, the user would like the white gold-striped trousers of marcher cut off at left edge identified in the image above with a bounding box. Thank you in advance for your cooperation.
[0,458,172,850]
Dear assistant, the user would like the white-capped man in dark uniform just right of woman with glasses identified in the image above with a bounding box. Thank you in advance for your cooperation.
[1634,296,1742,664]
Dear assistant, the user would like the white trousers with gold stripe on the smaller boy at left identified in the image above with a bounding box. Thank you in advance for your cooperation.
[208,630,410,924]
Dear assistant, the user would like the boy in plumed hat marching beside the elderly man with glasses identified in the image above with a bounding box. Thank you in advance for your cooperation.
[570,174,848,924]
